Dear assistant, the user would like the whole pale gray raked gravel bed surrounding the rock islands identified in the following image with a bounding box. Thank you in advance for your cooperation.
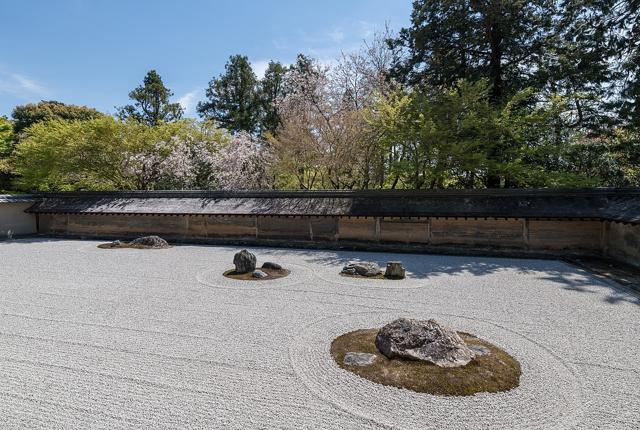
[0,239,640,430]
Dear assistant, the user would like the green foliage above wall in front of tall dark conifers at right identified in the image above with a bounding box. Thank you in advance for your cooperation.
[369,81,593,189]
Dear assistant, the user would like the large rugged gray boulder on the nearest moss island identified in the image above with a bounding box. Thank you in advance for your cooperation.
[376,318,476,367]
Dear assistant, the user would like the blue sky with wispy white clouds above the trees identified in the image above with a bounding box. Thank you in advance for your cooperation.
[0,0,411,116]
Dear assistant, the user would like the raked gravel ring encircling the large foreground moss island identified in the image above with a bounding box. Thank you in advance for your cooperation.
[289,313,582,430]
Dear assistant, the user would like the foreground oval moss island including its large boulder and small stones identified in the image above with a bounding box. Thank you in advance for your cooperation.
[331,318,521,396]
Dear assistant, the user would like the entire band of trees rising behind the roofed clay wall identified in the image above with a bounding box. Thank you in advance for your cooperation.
[0,0,640,190]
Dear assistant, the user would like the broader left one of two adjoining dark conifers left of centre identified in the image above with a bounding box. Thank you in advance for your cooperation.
[197,55,260,133]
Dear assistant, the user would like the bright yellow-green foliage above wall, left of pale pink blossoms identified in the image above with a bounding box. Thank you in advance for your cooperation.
[14,116,208,191]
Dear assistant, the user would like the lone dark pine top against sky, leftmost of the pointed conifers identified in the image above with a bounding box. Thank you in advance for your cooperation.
[118,70,184,126]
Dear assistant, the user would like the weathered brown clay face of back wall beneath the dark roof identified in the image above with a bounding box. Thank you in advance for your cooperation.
[39,214,608,253]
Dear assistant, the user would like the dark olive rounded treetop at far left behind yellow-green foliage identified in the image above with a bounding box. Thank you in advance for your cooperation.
[11,100,104,135]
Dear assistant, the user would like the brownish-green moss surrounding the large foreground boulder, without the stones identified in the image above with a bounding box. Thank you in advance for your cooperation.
[331,329,521,396]
